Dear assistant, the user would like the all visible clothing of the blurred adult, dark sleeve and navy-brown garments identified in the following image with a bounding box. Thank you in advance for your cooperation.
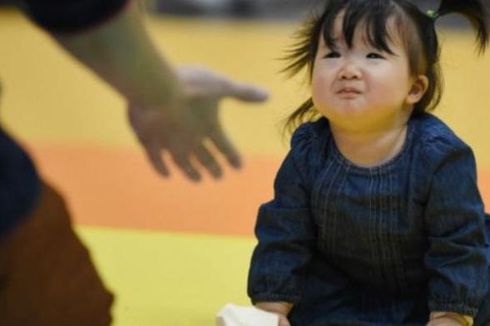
[0,0,129,326]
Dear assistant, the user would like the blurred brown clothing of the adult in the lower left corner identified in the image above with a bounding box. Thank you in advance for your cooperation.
[0,184,113,326]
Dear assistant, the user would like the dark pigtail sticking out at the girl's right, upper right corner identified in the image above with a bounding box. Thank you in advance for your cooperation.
[437,0,489,53]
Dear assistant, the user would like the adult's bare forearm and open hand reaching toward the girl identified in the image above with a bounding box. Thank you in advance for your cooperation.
[49,2,267,181]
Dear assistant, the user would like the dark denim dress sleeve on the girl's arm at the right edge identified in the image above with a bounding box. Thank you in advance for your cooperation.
[425,145,488,316]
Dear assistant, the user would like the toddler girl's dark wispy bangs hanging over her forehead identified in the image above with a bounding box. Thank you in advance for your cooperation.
[322,0,397,54]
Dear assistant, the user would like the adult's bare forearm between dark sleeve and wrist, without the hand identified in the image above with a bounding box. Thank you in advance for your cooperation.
[53,2,180,105]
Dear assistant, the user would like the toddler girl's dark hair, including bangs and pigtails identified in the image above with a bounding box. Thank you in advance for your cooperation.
[283,0,489,131]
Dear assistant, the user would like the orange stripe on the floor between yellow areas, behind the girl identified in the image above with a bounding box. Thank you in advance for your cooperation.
[27,146,490,235]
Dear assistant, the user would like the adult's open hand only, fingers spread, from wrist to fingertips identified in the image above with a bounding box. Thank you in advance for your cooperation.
[128,67,268,181]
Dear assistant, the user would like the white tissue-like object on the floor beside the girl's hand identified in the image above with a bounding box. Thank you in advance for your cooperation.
[216,303,279,326]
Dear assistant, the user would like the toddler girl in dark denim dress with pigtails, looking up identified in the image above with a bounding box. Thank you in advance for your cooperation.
[248,0,490,326]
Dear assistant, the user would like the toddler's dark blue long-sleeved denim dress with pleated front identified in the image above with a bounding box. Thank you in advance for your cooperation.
[248,114,490,326]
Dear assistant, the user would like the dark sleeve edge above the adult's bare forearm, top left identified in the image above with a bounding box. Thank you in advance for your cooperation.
[20,0,131,33]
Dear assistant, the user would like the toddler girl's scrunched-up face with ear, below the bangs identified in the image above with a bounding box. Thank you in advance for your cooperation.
[312,14,425,131]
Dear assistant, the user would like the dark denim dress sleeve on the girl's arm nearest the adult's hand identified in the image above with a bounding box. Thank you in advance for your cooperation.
[248,139,315,303]
